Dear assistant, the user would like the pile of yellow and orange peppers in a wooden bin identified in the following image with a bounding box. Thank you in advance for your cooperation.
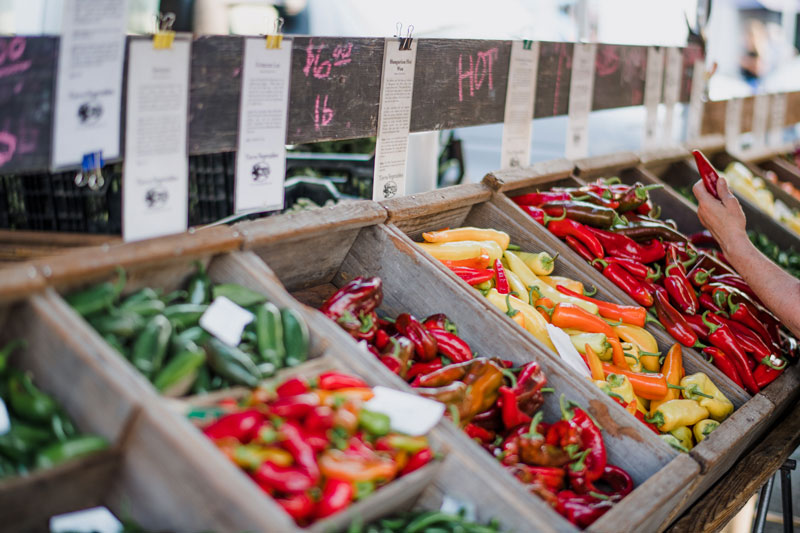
[418,227,734,451]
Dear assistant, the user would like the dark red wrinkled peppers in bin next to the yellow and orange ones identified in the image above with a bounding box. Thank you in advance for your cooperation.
[321,278,633,527]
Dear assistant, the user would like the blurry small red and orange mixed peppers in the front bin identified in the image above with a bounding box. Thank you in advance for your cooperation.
[198,372,433,526]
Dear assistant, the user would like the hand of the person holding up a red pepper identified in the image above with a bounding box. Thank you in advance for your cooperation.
[692,172,747,254]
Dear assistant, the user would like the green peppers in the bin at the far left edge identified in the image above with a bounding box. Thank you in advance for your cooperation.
[0,341,108,479]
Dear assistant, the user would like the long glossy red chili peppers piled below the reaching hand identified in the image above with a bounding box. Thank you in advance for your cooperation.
[512,172,797,394]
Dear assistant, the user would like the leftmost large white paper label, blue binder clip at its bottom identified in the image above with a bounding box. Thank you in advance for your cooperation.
[52,0,128,168]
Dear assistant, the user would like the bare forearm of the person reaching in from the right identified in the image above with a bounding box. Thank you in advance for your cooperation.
[725,238,800,335]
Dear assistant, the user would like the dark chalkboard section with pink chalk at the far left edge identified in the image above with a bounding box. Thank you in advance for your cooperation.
[0,37,58,174]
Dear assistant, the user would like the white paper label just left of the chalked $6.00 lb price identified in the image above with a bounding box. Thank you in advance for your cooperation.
[235,37,292,213]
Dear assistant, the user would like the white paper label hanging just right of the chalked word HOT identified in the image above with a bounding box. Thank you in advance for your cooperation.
[500,41,539,168]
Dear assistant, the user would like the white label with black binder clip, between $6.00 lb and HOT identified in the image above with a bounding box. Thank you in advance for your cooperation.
[372,39,417,200]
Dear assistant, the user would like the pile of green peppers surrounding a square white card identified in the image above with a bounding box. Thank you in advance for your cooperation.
[66,263,309,397]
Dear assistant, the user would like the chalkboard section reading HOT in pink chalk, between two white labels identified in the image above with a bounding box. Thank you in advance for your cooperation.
[411,39,511,131]
